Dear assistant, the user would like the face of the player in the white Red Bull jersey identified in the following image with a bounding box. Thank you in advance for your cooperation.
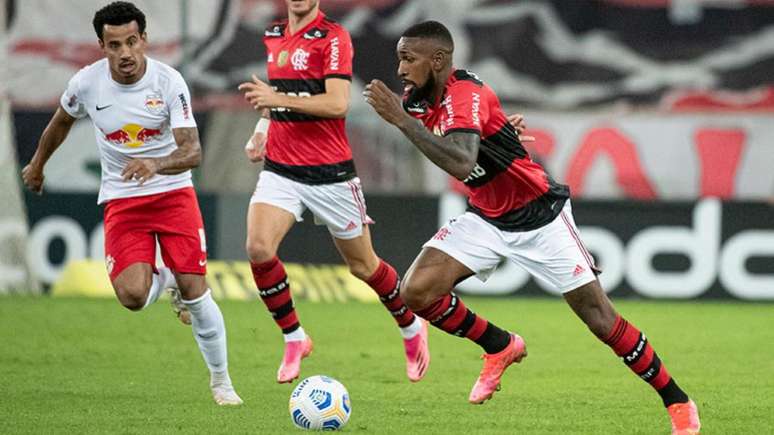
[99,21,147,84]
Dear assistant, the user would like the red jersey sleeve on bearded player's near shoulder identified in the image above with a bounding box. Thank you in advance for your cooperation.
[442,80,489,136]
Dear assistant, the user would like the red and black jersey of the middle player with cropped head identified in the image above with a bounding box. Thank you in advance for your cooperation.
[263,11,355,184]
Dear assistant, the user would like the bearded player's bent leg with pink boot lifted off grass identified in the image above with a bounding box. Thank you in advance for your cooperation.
[401,245,527,404]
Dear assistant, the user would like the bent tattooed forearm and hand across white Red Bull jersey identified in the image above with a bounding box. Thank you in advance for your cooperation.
[121,127,202,185]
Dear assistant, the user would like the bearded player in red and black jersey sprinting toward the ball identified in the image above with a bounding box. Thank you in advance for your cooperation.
[364,21,699,433]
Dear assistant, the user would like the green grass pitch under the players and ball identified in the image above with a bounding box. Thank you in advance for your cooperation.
[0,297,774,434]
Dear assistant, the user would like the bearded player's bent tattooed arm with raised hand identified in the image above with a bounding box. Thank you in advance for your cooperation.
[363,80,481,180]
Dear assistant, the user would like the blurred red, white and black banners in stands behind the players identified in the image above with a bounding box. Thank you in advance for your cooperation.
[6,0,774,194]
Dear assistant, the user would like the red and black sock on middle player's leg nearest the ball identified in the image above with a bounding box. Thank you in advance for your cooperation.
[250,257,301,334]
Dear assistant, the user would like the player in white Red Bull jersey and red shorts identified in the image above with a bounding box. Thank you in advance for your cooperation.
[22,1,242,405]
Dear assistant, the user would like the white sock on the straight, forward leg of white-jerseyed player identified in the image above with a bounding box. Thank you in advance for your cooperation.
[183,289,228,376]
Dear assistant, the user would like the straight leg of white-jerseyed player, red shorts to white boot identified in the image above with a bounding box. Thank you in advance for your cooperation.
[155,188,242,405]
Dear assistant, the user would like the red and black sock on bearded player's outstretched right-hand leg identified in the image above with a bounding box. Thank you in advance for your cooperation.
[603,316,672,390]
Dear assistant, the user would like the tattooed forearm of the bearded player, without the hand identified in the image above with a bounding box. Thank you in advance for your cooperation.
[399,118,481,180]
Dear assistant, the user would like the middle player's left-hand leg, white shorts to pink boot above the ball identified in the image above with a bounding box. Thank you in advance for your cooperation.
[245,171,313,383]
